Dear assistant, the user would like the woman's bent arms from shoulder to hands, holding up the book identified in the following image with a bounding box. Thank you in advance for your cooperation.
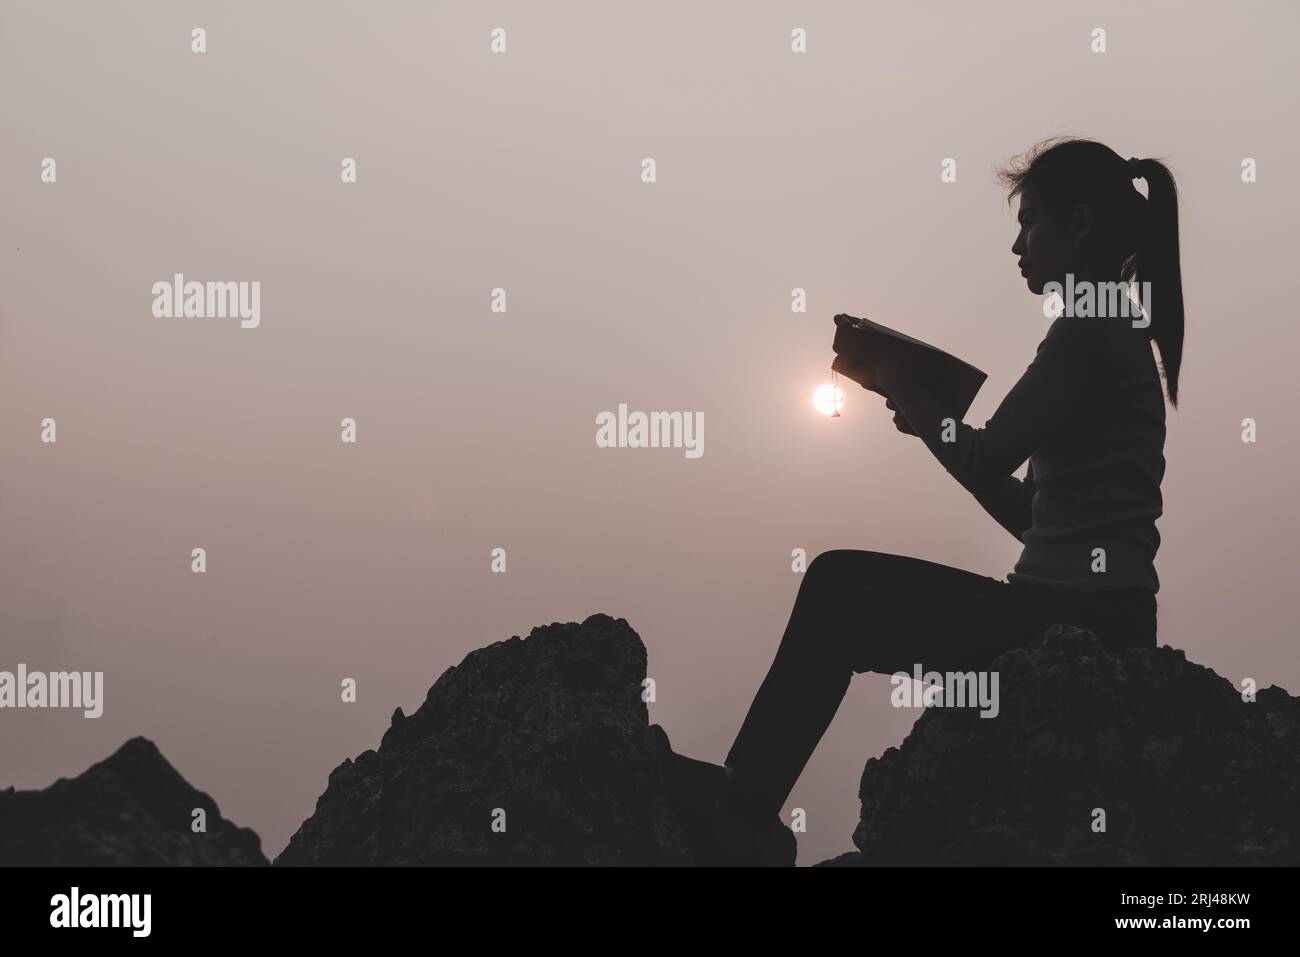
[875,317,1106,504]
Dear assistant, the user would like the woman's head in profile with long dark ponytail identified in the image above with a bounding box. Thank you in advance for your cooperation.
[1000,139,1183,406]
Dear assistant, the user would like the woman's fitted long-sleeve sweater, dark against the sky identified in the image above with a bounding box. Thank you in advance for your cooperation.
[896,316,1165,592]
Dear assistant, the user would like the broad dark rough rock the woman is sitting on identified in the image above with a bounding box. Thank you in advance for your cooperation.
[819,627,1300,866]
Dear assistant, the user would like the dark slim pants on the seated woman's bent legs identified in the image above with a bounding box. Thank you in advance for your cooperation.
[727,549,1156,815]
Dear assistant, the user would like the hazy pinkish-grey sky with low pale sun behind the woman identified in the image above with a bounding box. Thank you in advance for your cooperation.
[0,0,1300,863]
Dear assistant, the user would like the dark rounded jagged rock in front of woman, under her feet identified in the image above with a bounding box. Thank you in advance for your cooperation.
[276,614,759,865]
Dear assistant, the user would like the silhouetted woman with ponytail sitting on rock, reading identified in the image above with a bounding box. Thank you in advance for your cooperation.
[714,139,1183,863]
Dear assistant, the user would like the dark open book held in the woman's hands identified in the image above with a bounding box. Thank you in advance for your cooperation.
[831,312,988,420]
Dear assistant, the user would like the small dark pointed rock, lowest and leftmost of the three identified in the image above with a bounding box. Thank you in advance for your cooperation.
[0,737,268,866]
